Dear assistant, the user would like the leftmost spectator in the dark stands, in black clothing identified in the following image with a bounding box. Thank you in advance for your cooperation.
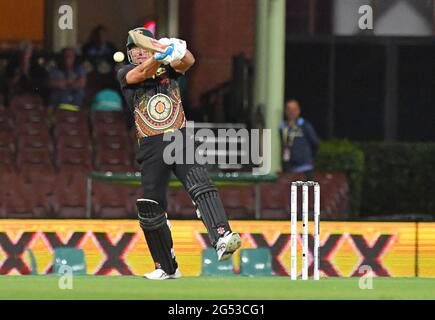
[6,42,48,104]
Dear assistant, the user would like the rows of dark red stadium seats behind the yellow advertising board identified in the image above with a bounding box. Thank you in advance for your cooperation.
[0,96,349,219]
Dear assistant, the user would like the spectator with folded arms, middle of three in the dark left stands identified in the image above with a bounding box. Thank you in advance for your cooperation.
[50,48,86,107]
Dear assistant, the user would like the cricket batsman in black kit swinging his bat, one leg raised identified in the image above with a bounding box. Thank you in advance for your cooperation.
[118,28,241,280]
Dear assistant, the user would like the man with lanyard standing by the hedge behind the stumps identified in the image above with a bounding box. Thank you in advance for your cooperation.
[279,99,320,180]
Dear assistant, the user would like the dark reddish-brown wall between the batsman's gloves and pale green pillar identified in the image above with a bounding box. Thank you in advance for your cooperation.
[180,0,255,108]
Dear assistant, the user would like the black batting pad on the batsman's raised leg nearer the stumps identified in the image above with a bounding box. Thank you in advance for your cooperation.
[186,167,231,246]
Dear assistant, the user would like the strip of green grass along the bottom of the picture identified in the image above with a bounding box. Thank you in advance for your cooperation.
[0,276,435,300]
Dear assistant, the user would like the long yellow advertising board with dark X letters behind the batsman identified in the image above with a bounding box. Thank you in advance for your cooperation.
[0,220,435,277]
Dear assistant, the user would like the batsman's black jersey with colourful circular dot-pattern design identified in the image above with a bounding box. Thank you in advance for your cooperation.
[118,64,186,140]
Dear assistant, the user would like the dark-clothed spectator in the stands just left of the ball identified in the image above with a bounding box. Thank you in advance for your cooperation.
[82,25,116,64]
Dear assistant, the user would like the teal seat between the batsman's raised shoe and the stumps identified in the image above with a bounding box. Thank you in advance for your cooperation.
[240,248,273,276]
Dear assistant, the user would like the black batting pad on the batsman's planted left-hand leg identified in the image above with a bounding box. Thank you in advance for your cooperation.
[136,199,177,274]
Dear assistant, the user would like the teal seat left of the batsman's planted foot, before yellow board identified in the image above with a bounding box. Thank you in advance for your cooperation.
[53,247,86,275]
